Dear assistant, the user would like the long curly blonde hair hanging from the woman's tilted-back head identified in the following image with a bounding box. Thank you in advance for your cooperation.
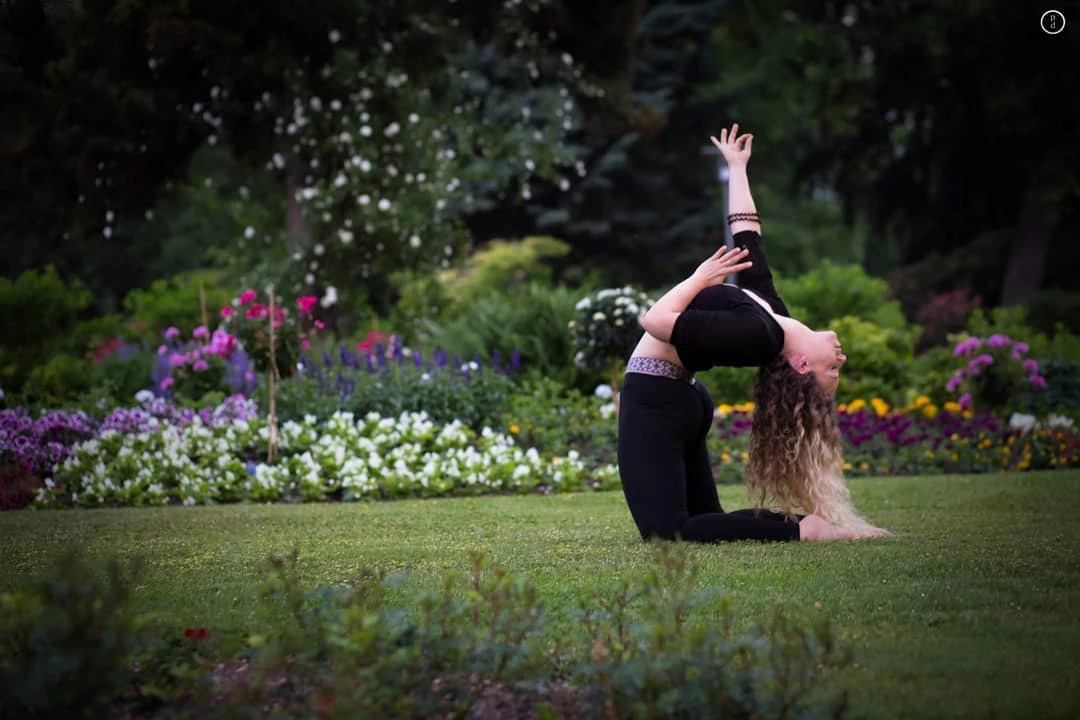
[746,355,881,533]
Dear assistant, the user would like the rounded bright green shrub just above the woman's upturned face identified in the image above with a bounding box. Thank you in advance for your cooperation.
[777,260,907,329]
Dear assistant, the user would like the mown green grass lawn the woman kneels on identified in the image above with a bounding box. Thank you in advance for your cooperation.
[0,471,1080,718]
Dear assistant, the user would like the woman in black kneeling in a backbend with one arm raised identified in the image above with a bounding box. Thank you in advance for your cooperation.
[619,124,885,542]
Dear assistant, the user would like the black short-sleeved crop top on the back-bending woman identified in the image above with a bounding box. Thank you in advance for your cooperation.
[671,230,788,372]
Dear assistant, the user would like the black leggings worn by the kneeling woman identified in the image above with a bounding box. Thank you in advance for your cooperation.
[619,372,799,543]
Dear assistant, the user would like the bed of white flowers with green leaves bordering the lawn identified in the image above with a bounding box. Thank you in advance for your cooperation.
[37,412,618,506]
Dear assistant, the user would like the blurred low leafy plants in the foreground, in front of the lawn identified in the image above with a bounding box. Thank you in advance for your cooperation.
[0,544,846,720]
